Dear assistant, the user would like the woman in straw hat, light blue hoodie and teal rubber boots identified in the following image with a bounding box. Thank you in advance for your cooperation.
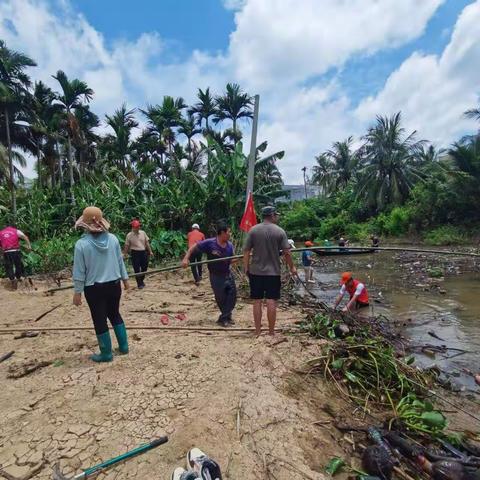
[73,207,128,362]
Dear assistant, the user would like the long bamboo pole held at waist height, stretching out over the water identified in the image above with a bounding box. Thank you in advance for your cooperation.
[44,246,480,293]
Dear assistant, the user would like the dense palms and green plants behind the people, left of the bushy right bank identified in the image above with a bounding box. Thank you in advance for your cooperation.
[0,41,284,273]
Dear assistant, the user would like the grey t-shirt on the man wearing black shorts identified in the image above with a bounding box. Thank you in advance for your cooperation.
[244,222,290,275]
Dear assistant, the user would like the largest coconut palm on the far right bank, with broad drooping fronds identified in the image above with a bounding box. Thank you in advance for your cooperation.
[357,112,425,211]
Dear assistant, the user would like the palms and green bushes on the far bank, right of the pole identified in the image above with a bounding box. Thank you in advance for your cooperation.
[283,110,480,245]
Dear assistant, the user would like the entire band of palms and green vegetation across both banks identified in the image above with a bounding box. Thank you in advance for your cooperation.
[0,40,480,272]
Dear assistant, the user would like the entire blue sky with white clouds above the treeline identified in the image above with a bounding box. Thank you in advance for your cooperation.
[0,0,480,183]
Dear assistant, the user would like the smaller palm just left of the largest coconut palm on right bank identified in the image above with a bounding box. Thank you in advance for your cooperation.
[312,137,359,194]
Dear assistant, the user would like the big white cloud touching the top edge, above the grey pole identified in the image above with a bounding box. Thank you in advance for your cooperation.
[230,0,444,88]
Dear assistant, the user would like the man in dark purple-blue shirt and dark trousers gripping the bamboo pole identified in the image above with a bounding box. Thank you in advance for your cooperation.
[182,222,236,327]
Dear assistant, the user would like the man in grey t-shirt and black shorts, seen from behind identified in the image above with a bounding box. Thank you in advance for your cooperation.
[243,206,297,337]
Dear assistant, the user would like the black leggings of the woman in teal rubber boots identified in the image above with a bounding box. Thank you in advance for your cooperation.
[84,280,123,335]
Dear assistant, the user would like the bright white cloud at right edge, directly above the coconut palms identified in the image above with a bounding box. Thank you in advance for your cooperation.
[356,1,480,146]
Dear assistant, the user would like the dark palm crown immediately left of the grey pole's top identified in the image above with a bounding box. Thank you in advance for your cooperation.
[213,83,253,145]
